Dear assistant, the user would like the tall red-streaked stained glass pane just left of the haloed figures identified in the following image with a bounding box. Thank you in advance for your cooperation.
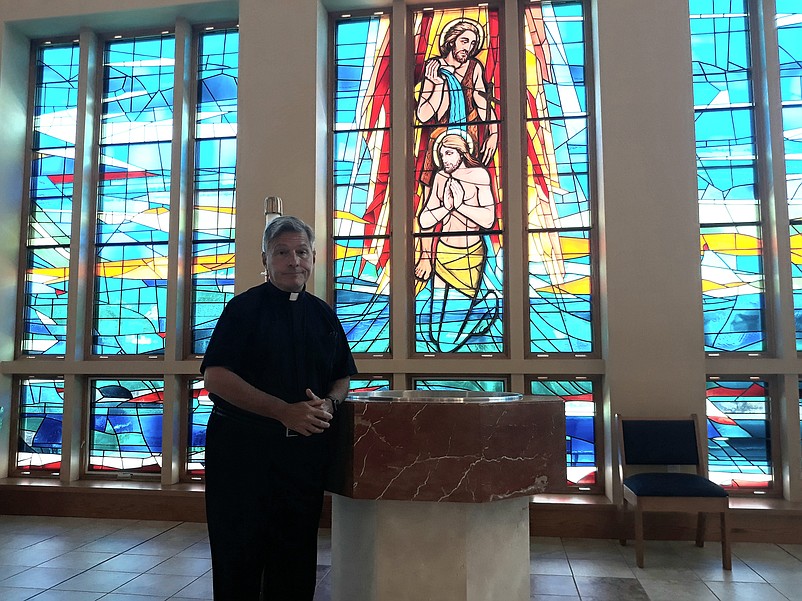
[332,15,391,354]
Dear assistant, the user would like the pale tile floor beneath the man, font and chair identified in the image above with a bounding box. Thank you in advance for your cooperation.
[0,516,802,601]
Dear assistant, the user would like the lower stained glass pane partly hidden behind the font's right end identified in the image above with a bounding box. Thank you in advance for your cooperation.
[530,378,599,490]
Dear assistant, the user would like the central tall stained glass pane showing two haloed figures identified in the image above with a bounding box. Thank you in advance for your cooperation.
[408,5,504,354]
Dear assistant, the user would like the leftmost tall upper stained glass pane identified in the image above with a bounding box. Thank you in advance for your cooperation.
[21,43,79,355]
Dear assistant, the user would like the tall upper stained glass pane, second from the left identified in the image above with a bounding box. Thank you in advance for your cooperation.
[92,34,175,355]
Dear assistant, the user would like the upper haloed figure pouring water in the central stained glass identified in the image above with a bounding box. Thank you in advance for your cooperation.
[415,19,498,281]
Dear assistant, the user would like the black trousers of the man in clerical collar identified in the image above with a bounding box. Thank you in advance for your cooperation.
[206,410,323,601]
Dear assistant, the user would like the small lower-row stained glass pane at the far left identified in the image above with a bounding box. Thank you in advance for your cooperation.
[17,378,64,473]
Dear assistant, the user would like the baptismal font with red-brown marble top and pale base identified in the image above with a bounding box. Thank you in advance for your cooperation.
[324,391,566,601]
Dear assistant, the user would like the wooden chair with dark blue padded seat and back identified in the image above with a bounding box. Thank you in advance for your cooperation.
[615,414,732,570]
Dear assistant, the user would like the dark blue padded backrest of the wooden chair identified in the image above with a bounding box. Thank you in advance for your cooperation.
[615,414,704,475]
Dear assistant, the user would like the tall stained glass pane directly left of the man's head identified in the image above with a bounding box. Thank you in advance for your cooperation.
[191,29,239,353]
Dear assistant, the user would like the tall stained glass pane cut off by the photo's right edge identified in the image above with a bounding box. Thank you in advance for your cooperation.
[777,0,802,351]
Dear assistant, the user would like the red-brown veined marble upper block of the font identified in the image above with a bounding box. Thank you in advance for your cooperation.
[324,397,566,503]
